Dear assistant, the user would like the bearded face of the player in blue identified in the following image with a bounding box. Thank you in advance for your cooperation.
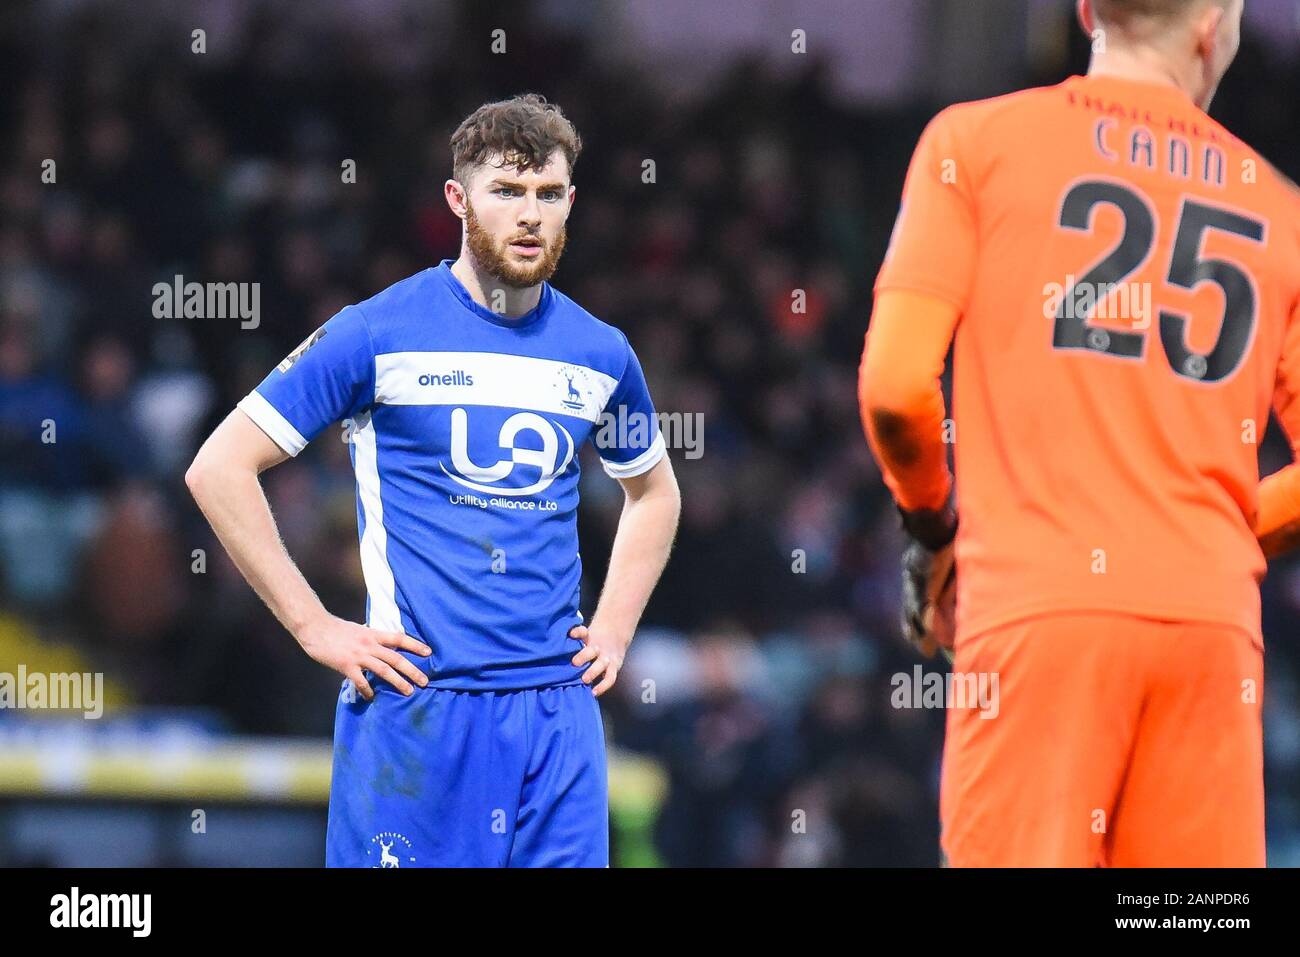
[465,164,568,289]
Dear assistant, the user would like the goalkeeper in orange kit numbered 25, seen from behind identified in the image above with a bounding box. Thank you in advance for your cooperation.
[861,0,1300,866]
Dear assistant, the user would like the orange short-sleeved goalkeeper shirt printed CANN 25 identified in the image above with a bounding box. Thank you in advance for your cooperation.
[876,77,1300,640]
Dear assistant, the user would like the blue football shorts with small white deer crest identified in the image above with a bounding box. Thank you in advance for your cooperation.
[325,680,610,867]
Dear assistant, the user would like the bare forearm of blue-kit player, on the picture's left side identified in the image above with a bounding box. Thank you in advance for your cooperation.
[185,452,328,637]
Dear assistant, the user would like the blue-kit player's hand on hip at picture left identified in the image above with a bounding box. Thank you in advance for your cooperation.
[295,615,433,701]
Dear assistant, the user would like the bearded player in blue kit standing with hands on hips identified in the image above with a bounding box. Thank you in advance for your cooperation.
[186,94,680,867]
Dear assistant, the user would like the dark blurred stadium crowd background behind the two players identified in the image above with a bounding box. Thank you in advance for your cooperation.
[0,0,1300,866]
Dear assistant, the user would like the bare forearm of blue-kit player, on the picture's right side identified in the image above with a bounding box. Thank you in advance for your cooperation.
[592,473,681,640]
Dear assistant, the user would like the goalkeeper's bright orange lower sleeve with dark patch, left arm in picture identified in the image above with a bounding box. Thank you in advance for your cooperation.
[858,291,957,511]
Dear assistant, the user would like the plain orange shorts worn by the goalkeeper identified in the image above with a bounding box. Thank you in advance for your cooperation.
[940,612,1265,867]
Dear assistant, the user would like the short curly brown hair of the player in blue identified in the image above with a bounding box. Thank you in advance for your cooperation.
[451,94,582,183]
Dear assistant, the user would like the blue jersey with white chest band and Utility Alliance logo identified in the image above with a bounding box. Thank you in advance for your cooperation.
[239,260,664,690]
